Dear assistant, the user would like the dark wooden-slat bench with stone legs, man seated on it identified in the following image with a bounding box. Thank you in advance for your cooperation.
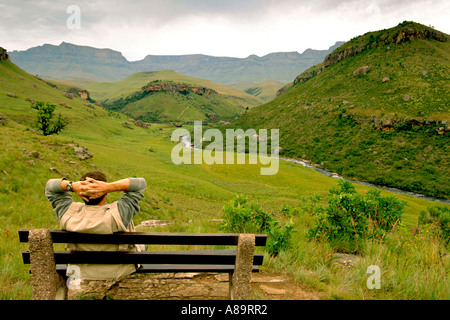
[19,229,267,300]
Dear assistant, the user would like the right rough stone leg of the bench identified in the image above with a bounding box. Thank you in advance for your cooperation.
[229,234,255,300]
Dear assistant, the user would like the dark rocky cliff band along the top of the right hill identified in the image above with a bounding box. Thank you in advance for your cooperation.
[323,21,449,69]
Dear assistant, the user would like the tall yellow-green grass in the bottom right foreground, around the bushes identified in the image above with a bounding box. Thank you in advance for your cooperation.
[272,196,450,300]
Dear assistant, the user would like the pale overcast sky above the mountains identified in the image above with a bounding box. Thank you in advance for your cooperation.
[0,0,450,61]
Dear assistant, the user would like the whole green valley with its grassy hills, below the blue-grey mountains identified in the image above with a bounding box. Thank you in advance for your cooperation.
[0,22,450,300]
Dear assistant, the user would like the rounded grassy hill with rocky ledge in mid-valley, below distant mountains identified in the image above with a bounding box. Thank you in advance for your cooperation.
[60,70,263,122]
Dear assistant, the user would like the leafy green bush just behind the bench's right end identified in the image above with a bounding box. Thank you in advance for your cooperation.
[220,195,294,256]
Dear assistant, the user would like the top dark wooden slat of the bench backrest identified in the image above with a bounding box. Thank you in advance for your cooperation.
[19,229,267,246]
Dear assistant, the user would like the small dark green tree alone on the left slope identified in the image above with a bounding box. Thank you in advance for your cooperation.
[31,101,69,136]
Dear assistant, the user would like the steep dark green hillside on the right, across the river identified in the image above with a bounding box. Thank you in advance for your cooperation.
[234,22,450,199]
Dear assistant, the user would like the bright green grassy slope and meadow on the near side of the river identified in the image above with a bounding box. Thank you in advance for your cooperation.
[0,45,450,300]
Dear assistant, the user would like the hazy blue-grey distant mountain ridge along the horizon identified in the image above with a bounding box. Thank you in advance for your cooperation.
[8,42,343,85]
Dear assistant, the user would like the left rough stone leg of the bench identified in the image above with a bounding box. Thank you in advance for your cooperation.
[28,229,67,300]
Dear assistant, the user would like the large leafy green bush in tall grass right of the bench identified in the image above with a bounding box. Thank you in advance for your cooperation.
[308,179,405,253]
